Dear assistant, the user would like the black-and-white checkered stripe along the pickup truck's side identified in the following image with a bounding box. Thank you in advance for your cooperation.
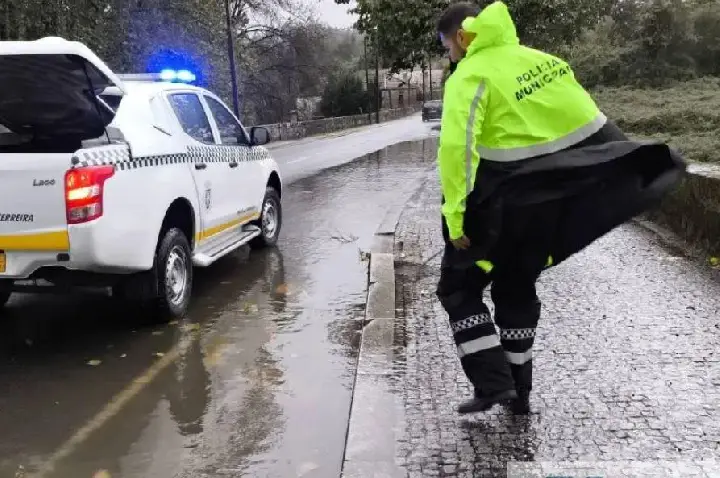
[73,145,270,171]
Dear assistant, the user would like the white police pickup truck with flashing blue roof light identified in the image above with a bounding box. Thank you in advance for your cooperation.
[0,38,282,318]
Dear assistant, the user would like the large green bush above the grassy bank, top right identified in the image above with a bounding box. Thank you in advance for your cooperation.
[557,0,720,87]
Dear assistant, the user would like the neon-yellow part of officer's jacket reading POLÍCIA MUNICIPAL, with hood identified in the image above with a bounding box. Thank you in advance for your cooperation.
[438,1,607,243]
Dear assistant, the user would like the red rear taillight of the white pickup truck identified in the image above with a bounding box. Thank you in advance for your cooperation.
[65,166,115,224]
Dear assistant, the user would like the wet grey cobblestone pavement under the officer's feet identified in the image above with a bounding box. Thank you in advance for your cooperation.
[396,167,720,477]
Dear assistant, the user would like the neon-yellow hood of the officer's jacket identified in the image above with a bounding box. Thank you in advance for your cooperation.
[462,1,520,55]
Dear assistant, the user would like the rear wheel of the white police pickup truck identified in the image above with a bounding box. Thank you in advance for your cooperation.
[155,228,193,319]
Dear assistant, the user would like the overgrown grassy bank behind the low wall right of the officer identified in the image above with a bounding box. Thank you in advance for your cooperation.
[593,78,720,163]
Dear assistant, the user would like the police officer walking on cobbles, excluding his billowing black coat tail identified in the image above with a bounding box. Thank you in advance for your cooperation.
[437,1,626,414]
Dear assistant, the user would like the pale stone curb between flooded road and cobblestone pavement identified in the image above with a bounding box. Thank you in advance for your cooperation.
[341,203,414,478]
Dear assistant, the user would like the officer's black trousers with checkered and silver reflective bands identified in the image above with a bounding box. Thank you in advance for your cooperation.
[437,198,561,395]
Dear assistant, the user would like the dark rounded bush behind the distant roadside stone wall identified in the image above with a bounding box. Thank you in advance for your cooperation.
[320,72,370,117]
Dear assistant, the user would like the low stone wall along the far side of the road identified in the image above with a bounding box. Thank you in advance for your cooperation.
[260,105,420,141]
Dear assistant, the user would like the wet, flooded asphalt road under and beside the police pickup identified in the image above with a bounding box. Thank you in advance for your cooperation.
[0,117,432,478]
